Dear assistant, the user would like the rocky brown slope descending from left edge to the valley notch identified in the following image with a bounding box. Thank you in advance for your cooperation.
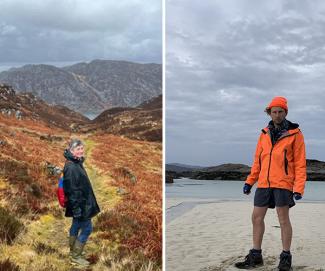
[0,85,90,131]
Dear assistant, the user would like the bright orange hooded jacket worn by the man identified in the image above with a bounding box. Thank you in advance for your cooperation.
[246,124,306,195]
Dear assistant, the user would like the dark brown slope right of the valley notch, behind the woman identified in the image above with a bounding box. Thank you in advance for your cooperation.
[80,95,162,142]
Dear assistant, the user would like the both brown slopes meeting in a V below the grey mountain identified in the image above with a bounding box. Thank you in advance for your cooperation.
[0,85,162,142]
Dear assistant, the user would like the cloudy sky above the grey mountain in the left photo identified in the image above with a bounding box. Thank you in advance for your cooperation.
[0,0,162,70]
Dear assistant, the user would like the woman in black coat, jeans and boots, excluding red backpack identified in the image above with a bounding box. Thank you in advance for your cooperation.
[63,139,100,266]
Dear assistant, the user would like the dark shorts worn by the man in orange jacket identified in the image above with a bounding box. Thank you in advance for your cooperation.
[254,188,296,209]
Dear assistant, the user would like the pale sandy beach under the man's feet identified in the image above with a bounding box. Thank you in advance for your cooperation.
[166,198,325,271]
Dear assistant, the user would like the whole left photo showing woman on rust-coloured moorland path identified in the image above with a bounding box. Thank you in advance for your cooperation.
[0,0,163,271]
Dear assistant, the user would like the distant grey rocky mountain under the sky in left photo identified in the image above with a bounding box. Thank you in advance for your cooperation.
[0,60,162,115]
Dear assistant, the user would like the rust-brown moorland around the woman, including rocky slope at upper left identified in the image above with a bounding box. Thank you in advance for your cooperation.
[0,93,162,271]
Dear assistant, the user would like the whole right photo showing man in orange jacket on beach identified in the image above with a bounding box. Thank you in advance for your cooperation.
[165,0,325,271]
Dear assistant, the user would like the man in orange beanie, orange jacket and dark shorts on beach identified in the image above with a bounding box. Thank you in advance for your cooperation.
[235,97,306,271]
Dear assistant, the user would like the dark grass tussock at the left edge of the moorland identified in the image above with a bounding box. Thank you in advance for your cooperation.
[0,207,24,245]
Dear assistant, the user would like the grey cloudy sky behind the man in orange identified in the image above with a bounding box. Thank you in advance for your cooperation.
[166,0,325,166]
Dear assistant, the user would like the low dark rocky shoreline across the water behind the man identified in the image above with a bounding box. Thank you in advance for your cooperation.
[166,162,325,182]
